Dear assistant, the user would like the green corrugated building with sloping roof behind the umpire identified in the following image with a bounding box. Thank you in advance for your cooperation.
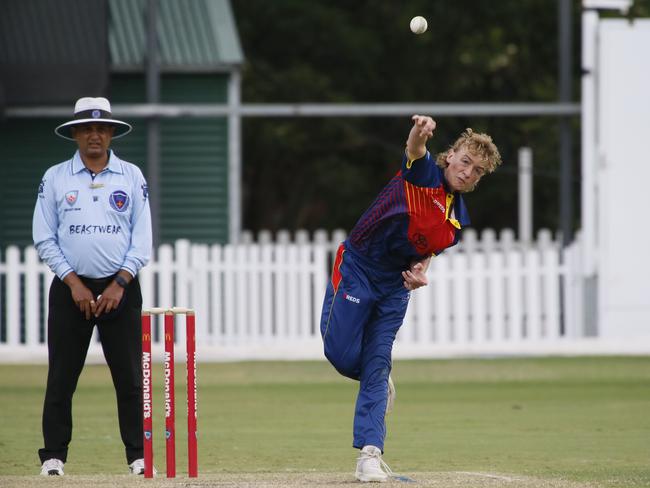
[0,0,243,248]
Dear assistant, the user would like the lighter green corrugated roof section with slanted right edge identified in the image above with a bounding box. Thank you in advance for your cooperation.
[108,0,244,72]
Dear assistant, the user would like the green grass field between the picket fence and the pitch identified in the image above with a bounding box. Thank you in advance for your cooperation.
[0,357,650,487]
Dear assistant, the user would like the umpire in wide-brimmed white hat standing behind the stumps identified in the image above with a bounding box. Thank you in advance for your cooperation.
[33,97,152,476]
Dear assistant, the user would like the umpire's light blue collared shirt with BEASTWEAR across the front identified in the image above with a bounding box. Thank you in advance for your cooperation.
[32,150,152,279]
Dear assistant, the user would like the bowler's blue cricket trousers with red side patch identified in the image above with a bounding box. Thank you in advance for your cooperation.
[320,244,409,452]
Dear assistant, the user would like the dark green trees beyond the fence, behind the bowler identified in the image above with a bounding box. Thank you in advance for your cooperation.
[233,0,650,236]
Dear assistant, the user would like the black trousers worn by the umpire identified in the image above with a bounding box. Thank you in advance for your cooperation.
[38,277,143,464]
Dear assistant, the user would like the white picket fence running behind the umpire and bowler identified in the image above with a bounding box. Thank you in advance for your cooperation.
[0,230,582,361]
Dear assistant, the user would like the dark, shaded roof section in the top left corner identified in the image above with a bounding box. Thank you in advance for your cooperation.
[0,0,110,104]
